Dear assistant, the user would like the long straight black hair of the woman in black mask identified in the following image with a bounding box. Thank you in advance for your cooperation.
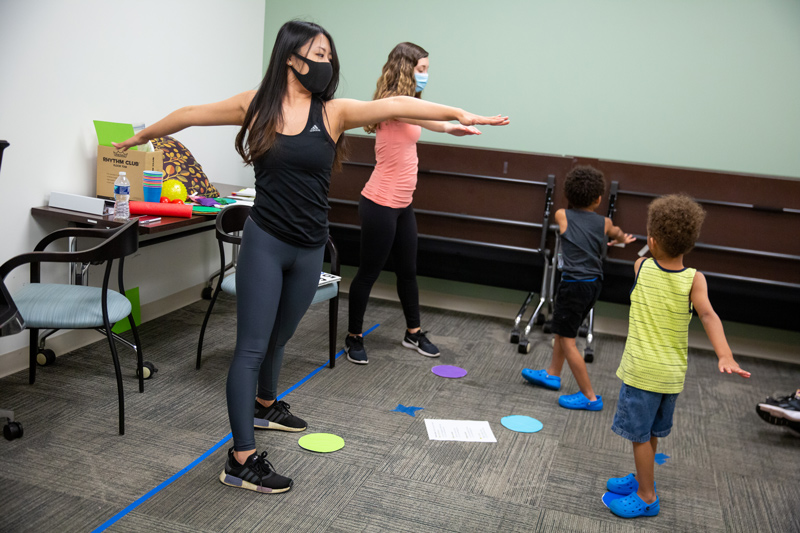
[231,20,344,170]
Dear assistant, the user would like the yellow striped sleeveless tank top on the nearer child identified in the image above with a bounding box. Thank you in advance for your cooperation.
[617,259,695,394]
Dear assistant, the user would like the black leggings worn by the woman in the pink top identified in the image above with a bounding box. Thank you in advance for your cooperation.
[348,196,420,334]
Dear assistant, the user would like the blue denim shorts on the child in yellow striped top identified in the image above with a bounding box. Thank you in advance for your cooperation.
[611,383,678,442]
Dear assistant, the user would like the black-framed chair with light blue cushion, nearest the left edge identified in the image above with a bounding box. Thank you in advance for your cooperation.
[0,219,144,435]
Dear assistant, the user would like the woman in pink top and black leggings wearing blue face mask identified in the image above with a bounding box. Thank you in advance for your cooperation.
[345,43,500,365]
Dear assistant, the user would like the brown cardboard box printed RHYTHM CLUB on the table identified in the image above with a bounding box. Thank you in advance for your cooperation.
[97,145,164,201]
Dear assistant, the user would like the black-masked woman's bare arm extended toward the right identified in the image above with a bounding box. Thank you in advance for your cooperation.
[326,96,508,139]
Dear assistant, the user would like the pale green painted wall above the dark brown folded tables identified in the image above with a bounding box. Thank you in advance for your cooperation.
[264,0,800,178]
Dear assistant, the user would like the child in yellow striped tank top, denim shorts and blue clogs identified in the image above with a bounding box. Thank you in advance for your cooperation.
[604,195,750,518]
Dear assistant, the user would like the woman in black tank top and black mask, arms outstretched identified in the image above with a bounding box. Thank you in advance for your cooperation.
[114,21,508,493]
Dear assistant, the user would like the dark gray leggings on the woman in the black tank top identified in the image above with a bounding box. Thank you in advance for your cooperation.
[226,219,325,451]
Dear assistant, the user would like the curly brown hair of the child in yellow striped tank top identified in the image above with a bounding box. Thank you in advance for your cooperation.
[647,194,706,257]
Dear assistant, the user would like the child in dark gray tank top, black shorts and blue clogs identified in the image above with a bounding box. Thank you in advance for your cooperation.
[522,166,636,411]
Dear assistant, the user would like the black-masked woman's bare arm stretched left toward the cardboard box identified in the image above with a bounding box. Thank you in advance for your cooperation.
[112,91,255,150]
